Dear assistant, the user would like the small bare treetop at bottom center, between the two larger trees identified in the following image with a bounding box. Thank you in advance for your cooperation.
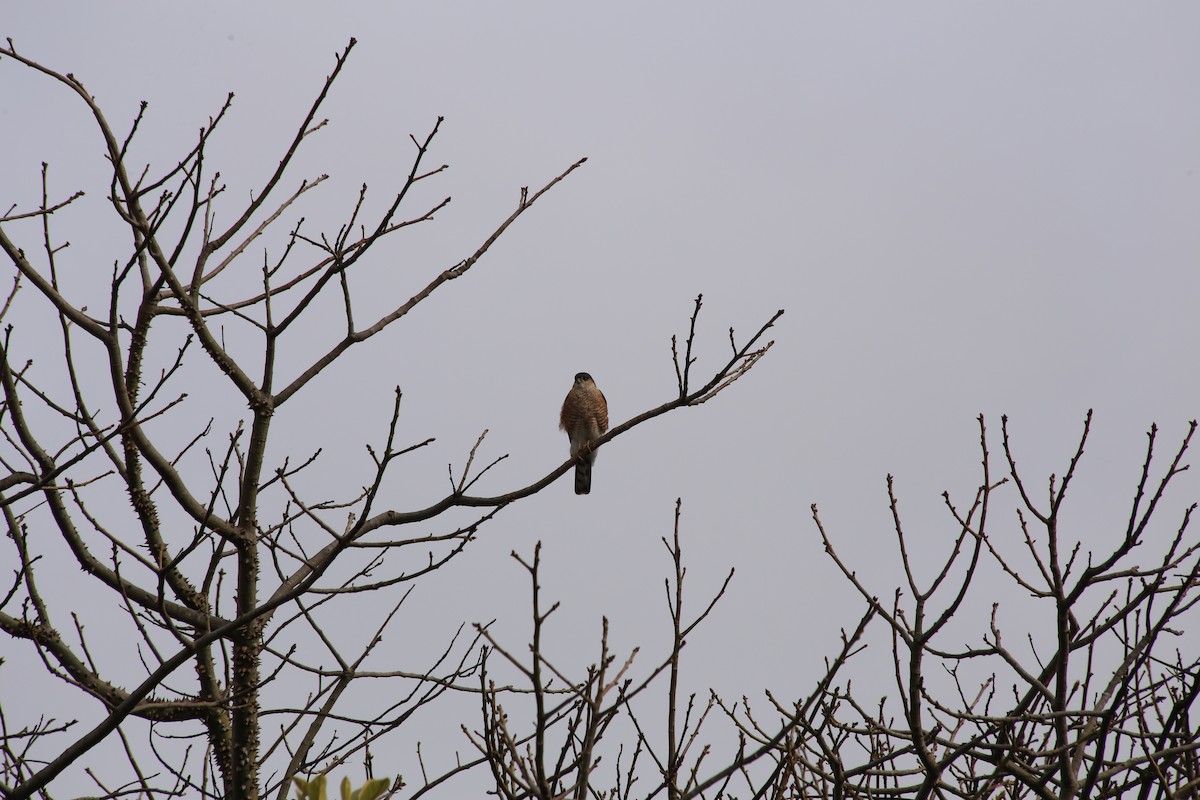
[464,500,875,800]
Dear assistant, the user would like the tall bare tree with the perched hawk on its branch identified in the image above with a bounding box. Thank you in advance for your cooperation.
[0,40,782,799]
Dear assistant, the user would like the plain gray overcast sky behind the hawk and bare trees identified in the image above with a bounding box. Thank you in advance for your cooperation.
[0,2,1200,796]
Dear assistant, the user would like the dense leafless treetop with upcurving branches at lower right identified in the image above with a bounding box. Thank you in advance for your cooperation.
[700,411,1200,800]
